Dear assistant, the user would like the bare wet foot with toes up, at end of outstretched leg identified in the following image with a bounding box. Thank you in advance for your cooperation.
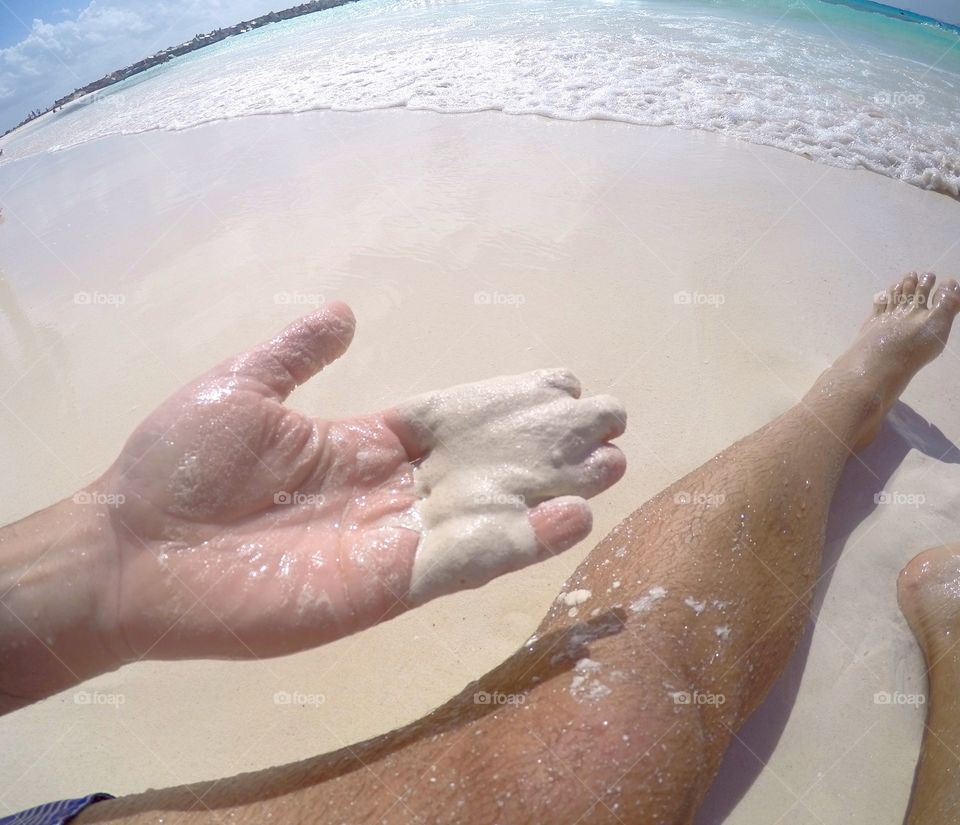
[811,272,960,449]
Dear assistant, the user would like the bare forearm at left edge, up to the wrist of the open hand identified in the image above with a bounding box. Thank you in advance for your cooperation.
[0,493,121,713]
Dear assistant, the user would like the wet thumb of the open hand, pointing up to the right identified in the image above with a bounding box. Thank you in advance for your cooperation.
[212,301,356,401]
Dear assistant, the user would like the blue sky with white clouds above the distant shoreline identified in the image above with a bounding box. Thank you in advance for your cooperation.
[0,0,960,133]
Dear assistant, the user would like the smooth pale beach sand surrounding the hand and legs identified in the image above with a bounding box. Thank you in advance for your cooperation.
[0,112,960,825]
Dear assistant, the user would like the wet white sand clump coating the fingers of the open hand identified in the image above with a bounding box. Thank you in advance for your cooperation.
[398,370,627,608]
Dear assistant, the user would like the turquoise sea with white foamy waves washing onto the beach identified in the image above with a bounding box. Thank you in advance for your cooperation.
[4,0,960,196]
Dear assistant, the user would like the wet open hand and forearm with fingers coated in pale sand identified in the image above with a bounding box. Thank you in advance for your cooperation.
[0,304,624,710]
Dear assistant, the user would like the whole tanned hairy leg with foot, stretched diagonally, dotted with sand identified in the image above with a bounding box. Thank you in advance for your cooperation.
[77,275,960,823]
